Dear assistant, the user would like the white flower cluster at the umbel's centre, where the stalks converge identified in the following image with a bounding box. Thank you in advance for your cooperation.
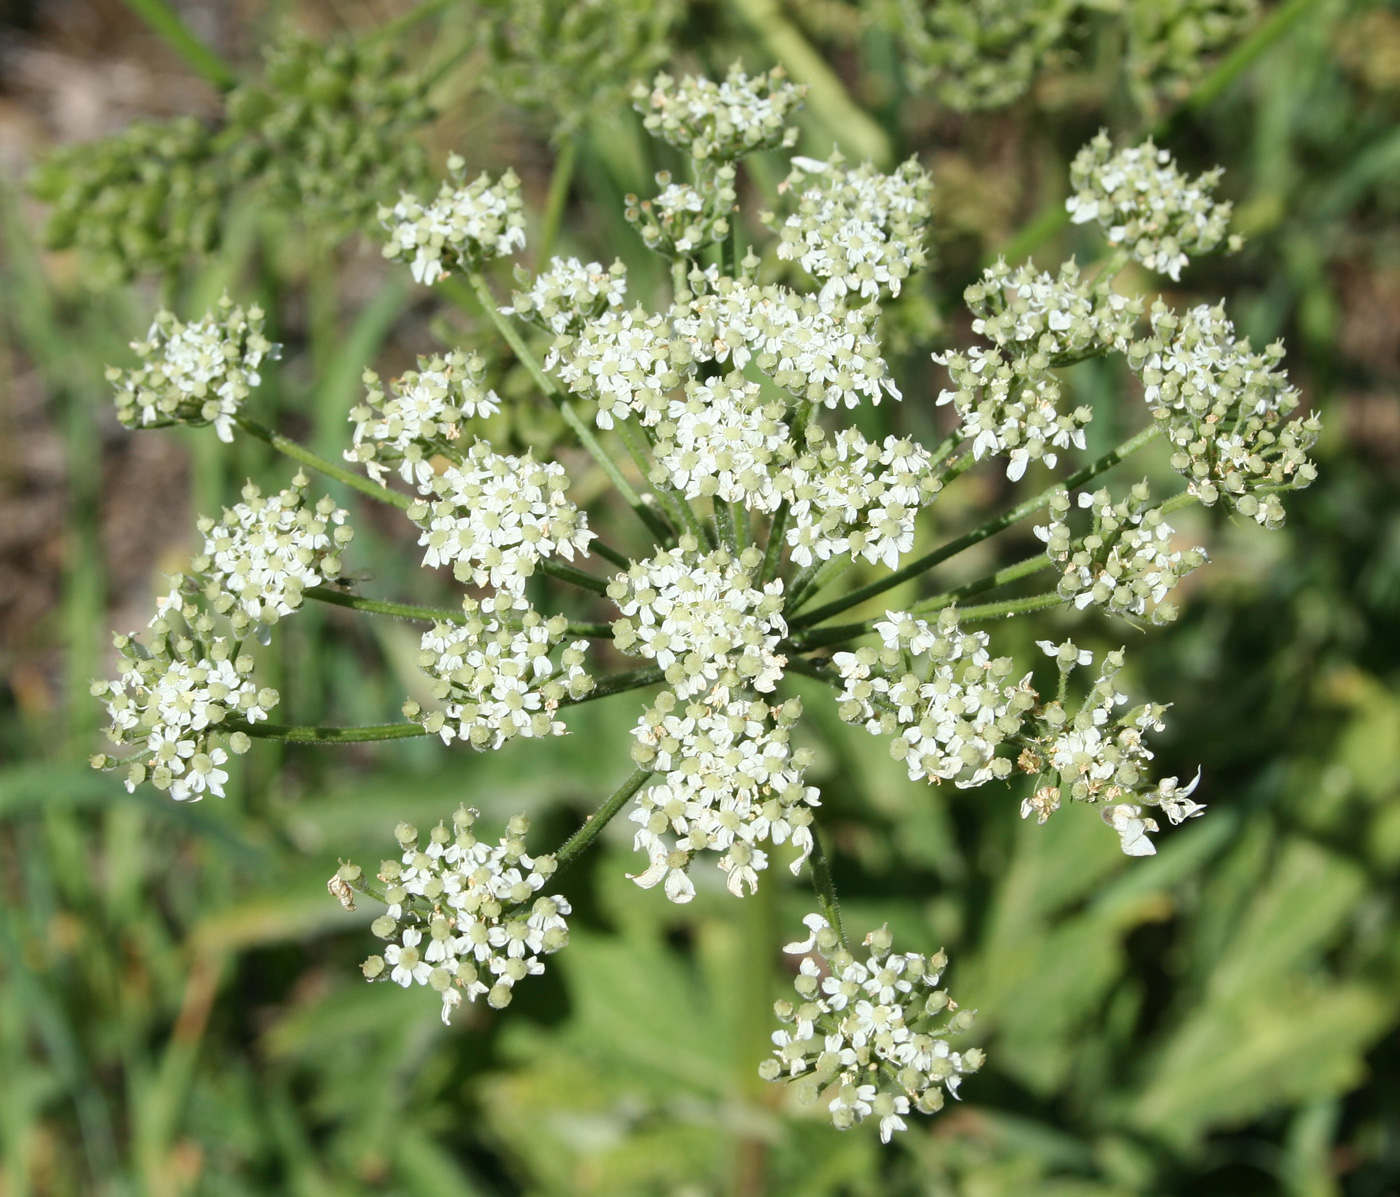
[608,546,787,699]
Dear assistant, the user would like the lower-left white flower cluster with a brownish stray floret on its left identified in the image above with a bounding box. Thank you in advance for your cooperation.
[366,808,571,1022]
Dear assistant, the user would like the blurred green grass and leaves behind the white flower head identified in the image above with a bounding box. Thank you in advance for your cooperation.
[0,0,1400,1197]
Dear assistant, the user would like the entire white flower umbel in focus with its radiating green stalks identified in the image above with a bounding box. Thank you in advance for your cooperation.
[97,67,1317,1140]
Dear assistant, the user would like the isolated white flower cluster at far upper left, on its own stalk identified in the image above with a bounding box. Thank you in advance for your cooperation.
[106,294,280,441]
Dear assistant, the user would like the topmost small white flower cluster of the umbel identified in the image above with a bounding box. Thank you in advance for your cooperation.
[631,63,806,162]
